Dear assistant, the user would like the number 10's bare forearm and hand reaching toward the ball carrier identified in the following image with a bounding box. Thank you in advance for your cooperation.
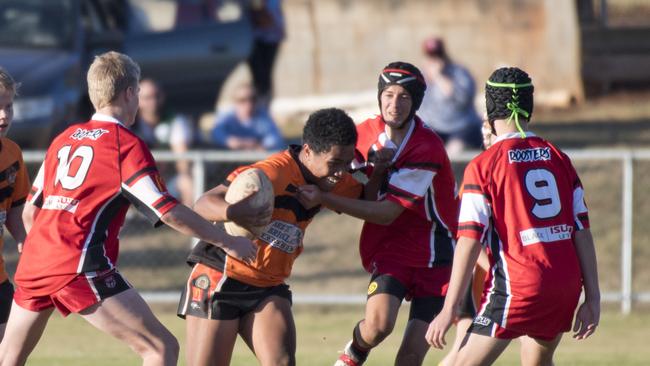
[160,204,257,262]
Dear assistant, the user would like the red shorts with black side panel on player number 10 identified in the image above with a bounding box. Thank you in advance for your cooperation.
[14,268,131,316]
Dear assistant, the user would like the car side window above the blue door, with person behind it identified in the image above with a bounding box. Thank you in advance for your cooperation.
[129,0,243,33]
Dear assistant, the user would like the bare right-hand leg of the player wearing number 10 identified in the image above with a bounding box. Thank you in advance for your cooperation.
[79,289,179,366]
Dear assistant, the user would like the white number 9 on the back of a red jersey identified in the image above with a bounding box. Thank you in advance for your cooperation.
[525,169,562,219]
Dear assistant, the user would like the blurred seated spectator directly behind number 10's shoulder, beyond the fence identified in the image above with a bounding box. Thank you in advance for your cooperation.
[134,79,196,205]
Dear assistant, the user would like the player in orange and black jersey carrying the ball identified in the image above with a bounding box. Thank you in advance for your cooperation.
[178,108,362,366]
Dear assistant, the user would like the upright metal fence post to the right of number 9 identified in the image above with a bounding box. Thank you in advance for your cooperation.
[621,152,634,315]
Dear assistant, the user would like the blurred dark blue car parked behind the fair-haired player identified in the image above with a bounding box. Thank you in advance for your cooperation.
[0,0,252,148]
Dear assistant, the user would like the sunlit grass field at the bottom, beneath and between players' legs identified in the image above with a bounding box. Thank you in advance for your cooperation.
[27,305,650,366]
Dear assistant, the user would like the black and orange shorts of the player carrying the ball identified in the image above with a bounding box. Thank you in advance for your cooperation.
[178,263,292,320]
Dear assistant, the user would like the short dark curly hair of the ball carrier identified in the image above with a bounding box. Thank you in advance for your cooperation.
[302,108,357,154]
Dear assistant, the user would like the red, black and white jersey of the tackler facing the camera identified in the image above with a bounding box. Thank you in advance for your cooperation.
[353,116,458,271]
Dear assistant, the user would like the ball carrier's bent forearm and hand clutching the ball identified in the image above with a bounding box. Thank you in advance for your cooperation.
[194,184,273,228]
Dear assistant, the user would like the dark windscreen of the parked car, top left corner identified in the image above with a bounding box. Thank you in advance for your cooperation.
[0,0,76,48]
